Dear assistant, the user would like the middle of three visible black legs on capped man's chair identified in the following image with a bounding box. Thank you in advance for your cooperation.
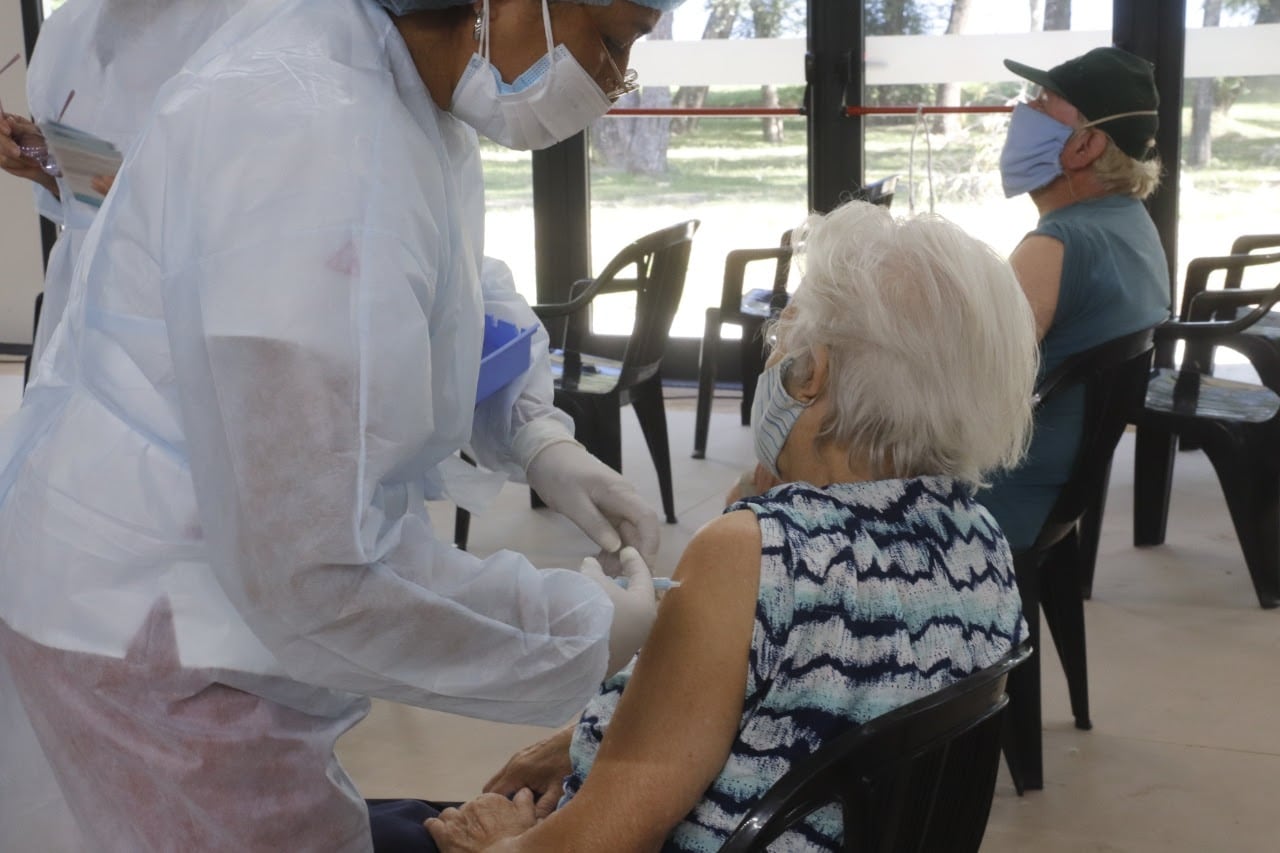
[1039,533,1093,731]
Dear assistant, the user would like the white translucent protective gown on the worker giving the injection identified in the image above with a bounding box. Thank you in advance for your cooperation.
[0,0,612,840]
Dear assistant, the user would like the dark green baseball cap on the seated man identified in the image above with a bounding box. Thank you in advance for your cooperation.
[1005,47,1160,160]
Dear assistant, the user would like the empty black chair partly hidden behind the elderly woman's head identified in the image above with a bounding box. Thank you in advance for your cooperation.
[694,174,897,459]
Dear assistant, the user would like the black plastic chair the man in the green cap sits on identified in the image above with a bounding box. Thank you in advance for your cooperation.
[1005,329,1153,794]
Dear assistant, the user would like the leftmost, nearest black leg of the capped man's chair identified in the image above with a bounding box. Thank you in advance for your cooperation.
[1002,550,1044,795]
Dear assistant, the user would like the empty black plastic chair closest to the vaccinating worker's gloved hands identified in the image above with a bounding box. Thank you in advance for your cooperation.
[534,219,699,524]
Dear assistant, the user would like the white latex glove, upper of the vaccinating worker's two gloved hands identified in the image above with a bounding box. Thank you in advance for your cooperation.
[525,442,658,557]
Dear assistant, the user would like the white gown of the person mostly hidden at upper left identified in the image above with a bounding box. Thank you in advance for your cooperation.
[27,0,247,365]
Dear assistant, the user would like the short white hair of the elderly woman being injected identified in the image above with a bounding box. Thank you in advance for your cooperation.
[773,201,1039,487]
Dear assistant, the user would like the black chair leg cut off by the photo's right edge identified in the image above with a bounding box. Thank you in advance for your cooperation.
[1204,434,1280,610]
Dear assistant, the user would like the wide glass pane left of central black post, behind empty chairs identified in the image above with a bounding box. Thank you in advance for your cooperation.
[591,3,808,338]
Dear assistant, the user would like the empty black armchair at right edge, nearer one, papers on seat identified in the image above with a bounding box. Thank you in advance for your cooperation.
[1133,255,1280,608]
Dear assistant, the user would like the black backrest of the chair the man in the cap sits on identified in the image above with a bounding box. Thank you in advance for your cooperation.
[1034,329,1153,549]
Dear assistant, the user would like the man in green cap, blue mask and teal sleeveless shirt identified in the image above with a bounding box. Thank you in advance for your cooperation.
[980,47,1169,552]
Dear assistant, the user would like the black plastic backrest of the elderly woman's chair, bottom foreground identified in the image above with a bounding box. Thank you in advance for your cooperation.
[721,644,1030,853]
